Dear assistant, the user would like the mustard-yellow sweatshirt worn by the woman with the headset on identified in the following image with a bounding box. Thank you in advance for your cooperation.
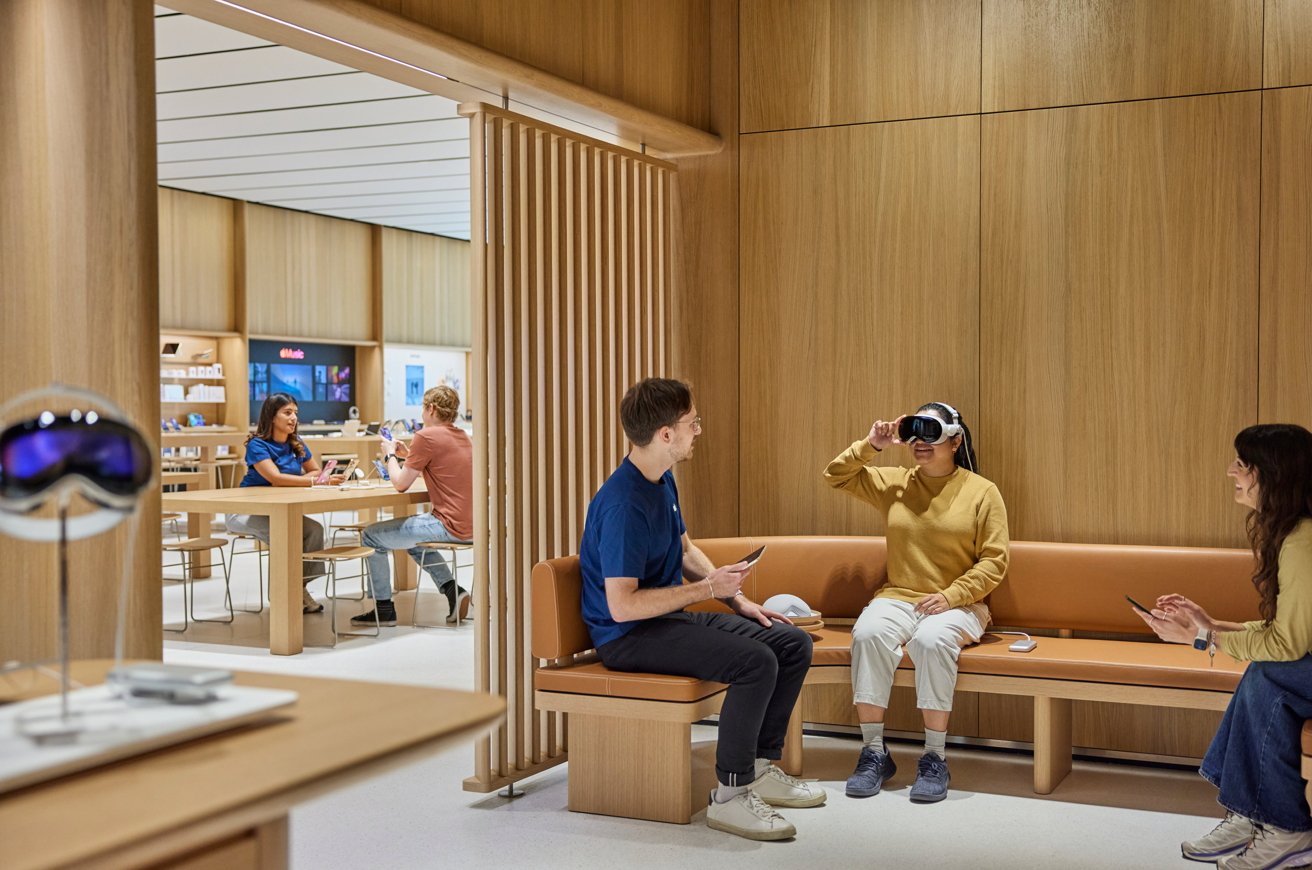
[824,438,1010,608]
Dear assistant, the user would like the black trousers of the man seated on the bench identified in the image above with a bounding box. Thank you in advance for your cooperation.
[597,610,811,786]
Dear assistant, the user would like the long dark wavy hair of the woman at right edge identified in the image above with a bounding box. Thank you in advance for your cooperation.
[1235,423,1312,625]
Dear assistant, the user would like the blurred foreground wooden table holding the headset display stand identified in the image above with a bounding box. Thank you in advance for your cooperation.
[0,661,505,870]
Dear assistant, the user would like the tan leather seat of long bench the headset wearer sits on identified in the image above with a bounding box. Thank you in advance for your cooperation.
[811,626,1243,692]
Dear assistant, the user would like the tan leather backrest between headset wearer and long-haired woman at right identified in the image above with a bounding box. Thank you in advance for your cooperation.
[986,541,1258,635]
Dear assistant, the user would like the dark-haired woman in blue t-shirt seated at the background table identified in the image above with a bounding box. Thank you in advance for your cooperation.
[226,392,341,613]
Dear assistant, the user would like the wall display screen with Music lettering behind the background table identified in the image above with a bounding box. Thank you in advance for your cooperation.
[247,340,357,423]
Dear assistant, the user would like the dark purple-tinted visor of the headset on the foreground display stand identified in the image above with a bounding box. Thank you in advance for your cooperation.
[0,417,151,497]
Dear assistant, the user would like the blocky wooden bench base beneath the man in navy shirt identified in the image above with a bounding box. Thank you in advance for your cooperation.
[534,690,729,824]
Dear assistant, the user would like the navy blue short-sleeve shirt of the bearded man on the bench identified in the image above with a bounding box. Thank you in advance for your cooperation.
[579,457,687,647]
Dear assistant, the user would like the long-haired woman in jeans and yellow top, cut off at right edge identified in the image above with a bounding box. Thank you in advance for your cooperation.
[1140,424,1312,870]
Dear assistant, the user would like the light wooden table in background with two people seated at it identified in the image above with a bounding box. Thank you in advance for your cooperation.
[160,478,428,656]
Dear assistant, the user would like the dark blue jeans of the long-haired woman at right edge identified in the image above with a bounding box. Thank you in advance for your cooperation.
[1199,655,1312,831]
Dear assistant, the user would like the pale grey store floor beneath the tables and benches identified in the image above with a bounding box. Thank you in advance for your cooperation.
[164,519,1219,870]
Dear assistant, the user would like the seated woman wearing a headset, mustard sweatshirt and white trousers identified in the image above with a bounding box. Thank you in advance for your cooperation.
[824,402,1010,803]
